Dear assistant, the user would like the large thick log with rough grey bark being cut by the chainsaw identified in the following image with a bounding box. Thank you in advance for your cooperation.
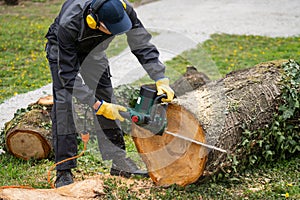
[132,61,290,186]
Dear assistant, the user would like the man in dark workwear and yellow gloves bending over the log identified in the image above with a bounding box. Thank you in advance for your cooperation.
[46,0,174,187]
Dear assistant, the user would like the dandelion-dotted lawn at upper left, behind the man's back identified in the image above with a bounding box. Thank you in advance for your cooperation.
[0,1,61,103]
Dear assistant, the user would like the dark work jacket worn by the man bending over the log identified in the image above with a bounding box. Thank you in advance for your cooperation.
[46,0,165,106]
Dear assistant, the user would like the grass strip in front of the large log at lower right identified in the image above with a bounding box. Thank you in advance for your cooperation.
[148,157,300,199]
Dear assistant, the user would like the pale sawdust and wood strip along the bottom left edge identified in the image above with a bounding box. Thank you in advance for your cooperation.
[0,175,154,200]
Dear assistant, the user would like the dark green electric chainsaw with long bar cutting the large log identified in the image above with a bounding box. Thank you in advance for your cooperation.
[120,85,226,153]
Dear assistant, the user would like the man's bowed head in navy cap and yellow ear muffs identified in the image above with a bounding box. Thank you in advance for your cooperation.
[86,0,132,35]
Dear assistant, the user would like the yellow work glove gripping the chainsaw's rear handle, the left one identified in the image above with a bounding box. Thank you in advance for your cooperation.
[96,101,127,122]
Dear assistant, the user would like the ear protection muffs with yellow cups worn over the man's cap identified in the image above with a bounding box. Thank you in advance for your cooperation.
[86,0,126,29]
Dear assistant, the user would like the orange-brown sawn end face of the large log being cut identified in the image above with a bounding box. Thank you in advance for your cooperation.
[132,104,207,186]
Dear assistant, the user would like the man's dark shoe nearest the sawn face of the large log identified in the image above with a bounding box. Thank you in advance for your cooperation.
[110,158,149,178]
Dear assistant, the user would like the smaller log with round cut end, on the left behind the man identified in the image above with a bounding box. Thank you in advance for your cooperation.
[5,97,52,160]
